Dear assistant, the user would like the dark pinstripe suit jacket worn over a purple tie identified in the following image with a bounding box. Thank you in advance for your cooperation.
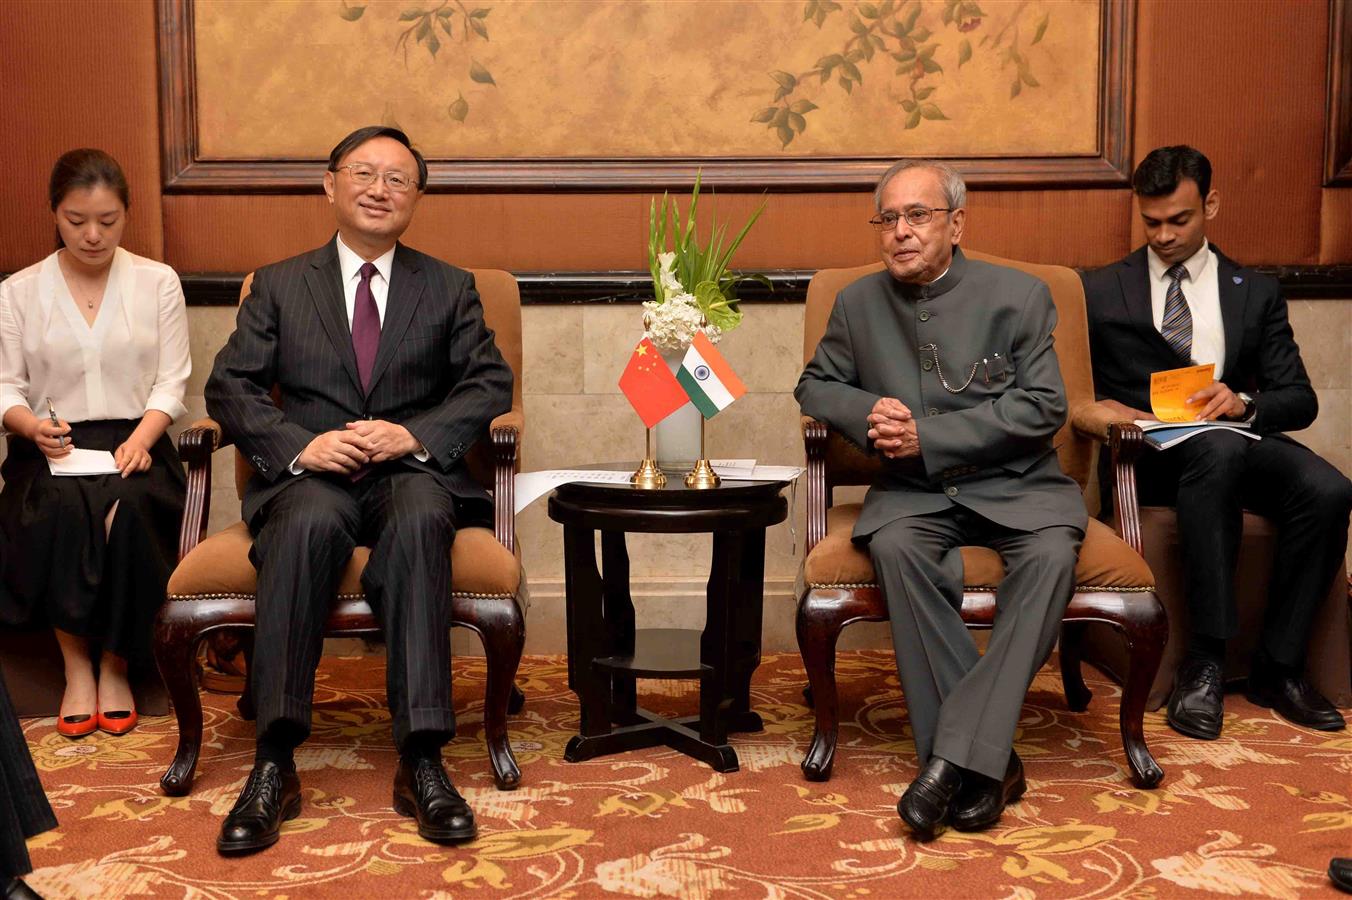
[206,238,512,524]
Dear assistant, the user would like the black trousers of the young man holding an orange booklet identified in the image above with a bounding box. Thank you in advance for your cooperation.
[1137,431,1352,666]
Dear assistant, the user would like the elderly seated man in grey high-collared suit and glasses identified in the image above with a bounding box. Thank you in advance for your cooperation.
[796,159,1087,839]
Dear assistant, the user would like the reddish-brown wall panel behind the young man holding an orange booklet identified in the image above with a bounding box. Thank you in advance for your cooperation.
[1132,0,1329,265]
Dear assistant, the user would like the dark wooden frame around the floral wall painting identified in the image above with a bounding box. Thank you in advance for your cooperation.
[157,0,1136,193]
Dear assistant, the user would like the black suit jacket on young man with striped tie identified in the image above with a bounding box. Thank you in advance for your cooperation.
[1083,245,1320,434]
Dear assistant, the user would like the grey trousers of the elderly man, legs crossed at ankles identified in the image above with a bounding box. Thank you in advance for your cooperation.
[869,507,1084,778]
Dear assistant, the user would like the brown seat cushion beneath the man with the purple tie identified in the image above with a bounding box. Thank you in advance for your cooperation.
[169,522,521,599]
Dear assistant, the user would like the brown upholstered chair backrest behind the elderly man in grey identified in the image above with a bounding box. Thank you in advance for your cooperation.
[803,250,1095,491]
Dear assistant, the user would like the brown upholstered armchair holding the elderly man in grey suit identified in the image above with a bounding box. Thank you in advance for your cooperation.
[796,251,1168,788]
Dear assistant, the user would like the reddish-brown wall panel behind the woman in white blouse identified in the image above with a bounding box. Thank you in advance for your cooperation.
[0,0,164,272]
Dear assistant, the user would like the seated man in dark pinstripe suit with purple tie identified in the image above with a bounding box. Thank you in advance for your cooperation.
[206,126,512,853]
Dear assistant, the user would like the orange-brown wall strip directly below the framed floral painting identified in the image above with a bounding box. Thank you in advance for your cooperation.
[164,191,1130,272]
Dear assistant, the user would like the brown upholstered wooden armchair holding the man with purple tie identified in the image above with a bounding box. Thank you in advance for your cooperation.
[154,264,526,796]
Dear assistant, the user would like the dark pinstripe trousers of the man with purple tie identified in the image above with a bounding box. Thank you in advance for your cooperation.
[249,465,456,750]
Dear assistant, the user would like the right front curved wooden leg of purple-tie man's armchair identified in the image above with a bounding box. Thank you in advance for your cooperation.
[452,597,526,791]
